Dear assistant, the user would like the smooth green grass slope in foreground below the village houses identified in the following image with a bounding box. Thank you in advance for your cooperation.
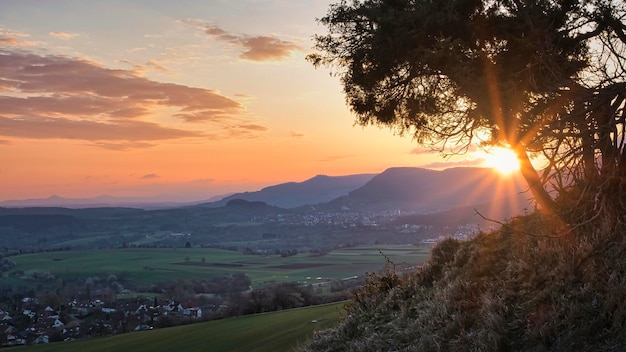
[7,303,344,352]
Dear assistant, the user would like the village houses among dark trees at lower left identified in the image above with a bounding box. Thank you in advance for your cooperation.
[0,298,206,346]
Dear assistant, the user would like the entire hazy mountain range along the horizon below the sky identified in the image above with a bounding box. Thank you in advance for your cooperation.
[0,167,531,218]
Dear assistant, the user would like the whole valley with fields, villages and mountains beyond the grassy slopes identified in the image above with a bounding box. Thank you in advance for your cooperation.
[0,168,524,345]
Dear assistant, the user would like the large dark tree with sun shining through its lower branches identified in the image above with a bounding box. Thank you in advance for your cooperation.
[307,0,626,220]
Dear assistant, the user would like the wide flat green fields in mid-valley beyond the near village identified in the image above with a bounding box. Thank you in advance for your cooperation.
[9,245,428,286]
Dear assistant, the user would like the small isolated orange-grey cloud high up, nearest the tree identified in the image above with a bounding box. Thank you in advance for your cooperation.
[183,19,302,61]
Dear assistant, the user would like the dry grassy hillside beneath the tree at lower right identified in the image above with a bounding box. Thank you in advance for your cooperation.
[303,214,626,352]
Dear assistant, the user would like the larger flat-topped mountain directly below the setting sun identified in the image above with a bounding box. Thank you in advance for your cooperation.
[316,167,530,215]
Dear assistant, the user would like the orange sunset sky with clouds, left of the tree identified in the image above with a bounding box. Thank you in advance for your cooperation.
[0,0,482,201]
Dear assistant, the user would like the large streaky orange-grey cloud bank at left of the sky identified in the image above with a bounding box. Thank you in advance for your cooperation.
[0,49,267,144]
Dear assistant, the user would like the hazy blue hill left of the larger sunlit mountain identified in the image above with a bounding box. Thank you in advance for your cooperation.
[201,174,375,208]
